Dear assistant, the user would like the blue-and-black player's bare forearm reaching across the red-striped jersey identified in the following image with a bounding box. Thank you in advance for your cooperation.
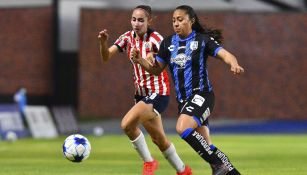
[131,49,166,75]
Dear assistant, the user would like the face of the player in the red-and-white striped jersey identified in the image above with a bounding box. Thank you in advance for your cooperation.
[131,9,148,36]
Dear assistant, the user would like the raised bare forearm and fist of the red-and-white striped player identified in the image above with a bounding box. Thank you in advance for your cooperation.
[98,29,119,62]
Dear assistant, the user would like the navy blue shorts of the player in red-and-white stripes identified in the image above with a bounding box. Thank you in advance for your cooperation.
[134,93,169,114]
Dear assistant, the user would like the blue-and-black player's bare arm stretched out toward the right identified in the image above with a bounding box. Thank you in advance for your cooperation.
[217,48,244,74]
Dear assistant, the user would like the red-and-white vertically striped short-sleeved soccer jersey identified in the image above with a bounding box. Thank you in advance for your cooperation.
[114,29,170,96]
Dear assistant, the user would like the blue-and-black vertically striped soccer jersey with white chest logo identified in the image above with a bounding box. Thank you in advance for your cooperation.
[156,31,222,101]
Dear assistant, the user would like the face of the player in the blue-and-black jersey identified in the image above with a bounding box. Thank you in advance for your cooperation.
[173,9,193,37]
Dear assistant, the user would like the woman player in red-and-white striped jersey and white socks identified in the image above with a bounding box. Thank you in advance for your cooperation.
[98,5,192,175]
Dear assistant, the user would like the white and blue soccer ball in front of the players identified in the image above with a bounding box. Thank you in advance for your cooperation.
[63,134,91,162]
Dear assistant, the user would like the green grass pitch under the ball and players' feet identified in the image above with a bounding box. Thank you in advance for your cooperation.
[0,135,307,175]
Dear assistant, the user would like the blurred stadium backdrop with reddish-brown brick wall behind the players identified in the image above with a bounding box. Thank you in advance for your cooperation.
[0,0,307,137]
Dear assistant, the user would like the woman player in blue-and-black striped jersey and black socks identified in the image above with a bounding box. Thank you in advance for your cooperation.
[132,5,244,175]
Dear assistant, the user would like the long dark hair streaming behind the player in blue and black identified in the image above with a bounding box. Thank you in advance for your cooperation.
[176,5,223,43]
